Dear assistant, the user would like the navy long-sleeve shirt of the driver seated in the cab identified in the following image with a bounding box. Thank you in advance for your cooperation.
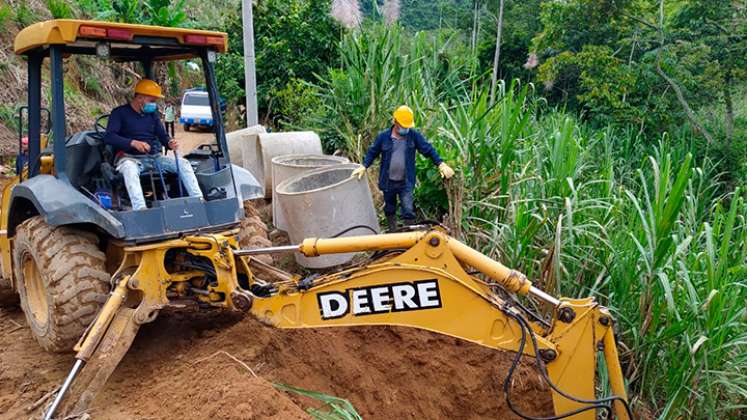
[104,104,170,155]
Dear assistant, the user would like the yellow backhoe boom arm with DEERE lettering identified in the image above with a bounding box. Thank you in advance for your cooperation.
[247,230,628,420]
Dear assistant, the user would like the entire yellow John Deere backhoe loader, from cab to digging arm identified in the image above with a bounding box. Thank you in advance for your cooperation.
[0,20,631,420]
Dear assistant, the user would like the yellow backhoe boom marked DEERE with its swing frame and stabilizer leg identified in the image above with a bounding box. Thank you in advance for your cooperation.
[52,229,628,420]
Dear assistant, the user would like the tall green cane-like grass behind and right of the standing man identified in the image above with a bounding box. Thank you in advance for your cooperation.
[308,26,747,418]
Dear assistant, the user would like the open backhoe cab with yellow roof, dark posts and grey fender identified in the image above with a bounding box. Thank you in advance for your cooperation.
[8,19,245,243]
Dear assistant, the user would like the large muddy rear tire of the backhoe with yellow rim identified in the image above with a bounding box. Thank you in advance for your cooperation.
[13,216,110,352]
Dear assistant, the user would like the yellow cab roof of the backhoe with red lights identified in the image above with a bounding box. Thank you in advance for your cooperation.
[14,19,228,61]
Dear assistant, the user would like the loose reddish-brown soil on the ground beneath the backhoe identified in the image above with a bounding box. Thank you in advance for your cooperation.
[0,137,552,420]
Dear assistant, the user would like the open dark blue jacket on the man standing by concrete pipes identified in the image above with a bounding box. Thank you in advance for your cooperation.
[363,128,443,191]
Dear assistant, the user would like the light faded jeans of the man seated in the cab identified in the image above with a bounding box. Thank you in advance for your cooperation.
[117,155,202,210]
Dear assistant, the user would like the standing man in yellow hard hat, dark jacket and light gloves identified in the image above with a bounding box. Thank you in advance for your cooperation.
[353,105,454,231]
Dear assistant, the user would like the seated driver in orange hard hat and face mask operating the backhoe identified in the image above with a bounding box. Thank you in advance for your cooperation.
[104,79,203,210]
